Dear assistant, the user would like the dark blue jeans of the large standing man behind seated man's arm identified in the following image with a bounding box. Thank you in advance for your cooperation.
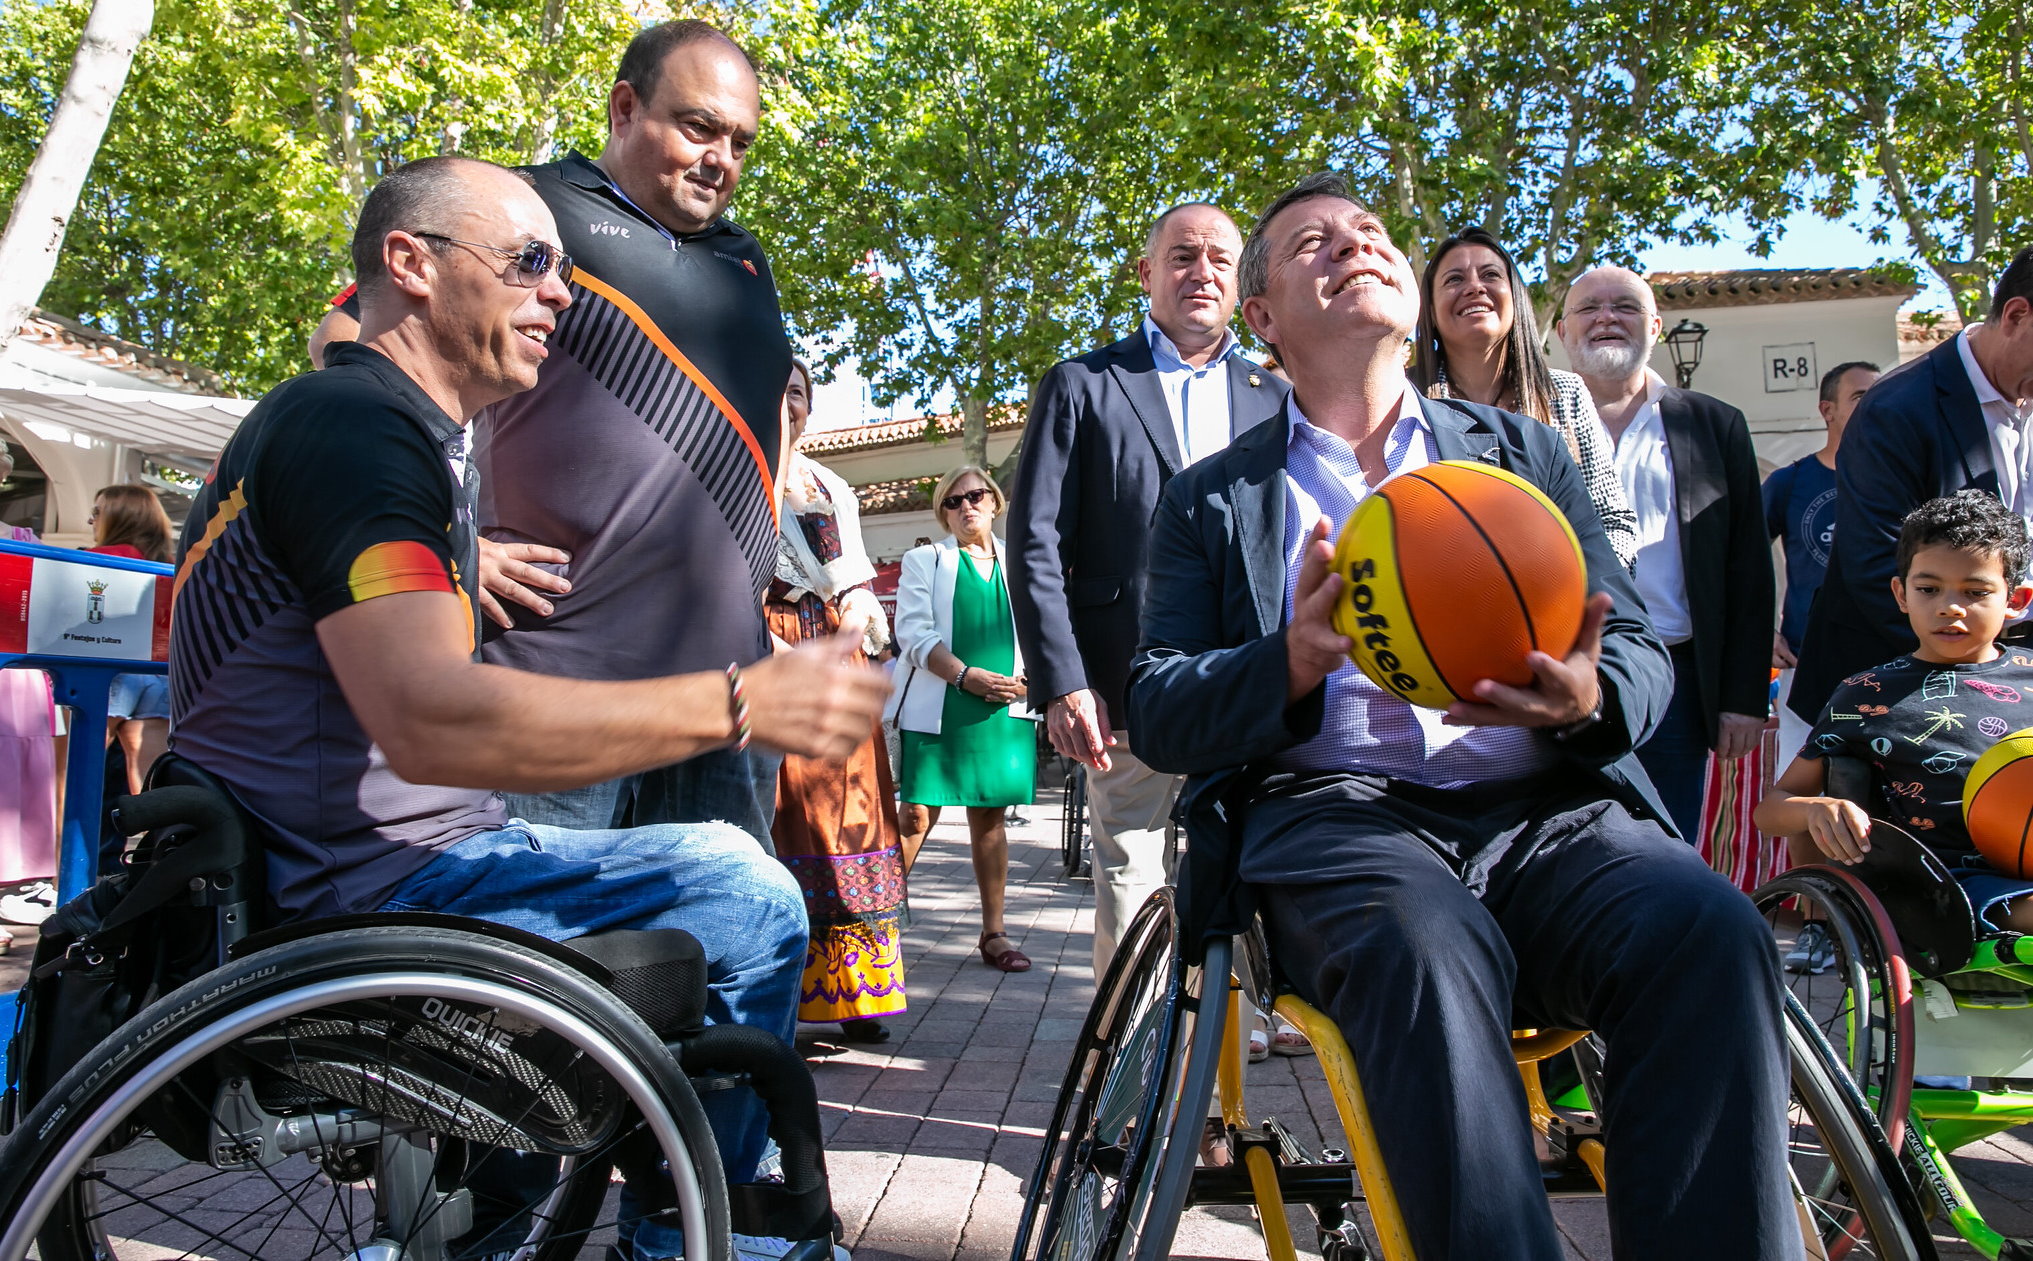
[502,748,783,854]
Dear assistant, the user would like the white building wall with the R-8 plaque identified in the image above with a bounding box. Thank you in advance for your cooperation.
[1551,297,1905,470]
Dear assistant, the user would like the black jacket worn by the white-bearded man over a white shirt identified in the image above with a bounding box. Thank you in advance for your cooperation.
[1659,386,1779,744]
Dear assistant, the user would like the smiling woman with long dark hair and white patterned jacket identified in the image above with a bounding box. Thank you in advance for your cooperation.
[1411,228,1639,567]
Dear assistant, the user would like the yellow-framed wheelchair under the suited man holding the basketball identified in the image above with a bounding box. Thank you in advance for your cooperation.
[1010,797,1935,1261]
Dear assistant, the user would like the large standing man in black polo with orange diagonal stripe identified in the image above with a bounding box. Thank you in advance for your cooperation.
[313,20,791,838]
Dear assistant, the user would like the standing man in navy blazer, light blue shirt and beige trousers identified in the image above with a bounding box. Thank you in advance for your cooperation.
[1010,201,1287,976]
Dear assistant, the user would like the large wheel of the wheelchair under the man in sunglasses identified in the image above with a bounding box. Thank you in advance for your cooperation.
[0,925,730,1261]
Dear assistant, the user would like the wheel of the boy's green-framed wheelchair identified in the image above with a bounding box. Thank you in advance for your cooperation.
[1752,866,1913,1147]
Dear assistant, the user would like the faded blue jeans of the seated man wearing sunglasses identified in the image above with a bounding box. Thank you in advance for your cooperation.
[380,820,807,1255]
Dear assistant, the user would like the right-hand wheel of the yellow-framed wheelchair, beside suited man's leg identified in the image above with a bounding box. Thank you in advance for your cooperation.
[1789,995,1935,1261]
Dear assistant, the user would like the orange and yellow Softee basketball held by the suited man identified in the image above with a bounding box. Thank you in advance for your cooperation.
[1334,460,1588,710]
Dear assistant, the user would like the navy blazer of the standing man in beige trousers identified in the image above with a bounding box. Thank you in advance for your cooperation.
[1008,327,1291,728]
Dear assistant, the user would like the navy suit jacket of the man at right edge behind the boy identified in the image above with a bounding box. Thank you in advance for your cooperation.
[1791,338,1998,722]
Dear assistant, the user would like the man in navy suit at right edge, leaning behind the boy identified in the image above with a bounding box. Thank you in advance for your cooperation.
[1787,246,2033,722]
